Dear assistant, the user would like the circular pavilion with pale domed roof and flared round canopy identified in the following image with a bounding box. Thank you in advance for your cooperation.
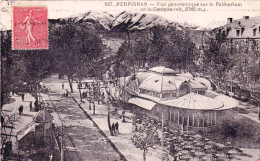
[122,67,239,131]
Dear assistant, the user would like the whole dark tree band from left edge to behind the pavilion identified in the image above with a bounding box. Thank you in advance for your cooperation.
[1,19,199,108]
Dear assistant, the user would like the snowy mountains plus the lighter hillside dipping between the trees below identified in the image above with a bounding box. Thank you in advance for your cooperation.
[49,11,196,54]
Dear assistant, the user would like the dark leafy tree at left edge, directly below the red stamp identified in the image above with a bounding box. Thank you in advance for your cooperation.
[1,31,53,105]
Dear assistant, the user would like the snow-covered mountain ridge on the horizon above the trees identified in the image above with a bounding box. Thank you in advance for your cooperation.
[52,11,184,31]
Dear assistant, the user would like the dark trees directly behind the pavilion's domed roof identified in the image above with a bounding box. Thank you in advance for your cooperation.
[112,26,196,75]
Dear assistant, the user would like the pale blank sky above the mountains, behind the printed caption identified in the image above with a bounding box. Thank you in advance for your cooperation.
[0,0,260,29]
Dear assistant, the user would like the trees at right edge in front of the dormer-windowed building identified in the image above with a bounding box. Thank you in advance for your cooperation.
[202,30,260,90]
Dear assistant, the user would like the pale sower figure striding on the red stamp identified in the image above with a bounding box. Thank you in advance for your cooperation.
[20,10,41,45]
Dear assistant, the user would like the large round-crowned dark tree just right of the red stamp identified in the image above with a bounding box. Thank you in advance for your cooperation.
[49,20,102,92]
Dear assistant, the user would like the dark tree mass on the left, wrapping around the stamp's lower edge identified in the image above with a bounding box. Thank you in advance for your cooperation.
[1,22,103,108]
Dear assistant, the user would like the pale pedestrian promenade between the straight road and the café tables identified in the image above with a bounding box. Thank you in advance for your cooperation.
[65,85,171,161]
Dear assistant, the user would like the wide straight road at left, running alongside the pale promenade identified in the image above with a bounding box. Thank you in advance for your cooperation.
[42,78,124,161]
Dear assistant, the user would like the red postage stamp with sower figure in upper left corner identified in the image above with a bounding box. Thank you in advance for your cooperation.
[12,6,49,50]
